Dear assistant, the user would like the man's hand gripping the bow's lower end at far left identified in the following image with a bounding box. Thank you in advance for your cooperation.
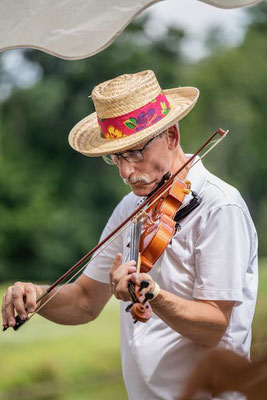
[2,282,45,327]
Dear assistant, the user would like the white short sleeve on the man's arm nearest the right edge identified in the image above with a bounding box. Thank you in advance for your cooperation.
[193,204,254,305]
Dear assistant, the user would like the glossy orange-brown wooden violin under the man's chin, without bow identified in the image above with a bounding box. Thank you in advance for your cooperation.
[126,174,200,323]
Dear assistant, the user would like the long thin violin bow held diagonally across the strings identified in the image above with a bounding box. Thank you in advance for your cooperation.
[2,128,229,331]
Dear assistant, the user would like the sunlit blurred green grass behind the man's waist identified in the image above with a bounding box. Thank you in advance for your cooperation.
[0,260,267,400]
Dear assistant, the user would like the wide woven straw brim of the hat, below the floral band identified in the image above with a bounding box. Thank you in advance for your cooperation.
[69,87,199,157]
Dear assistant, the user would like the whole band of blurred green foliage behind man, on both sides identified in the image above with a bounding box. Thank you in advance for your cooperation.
[0,4,267,282]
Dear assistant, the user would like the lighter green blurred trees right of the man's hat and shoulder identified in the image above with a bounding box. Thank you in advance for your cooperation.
[181,2,267,256]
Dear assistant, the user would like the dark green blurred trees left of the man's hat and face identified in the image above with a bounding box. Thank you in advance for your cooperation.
[0,18,187,281]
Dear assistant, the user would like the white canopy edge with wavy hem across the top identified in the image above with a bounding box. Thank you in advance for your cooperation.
[0,0,262,60]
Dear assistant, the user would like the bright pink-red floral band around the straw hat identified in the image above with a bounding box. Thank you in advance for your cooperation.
[98,93,171,139]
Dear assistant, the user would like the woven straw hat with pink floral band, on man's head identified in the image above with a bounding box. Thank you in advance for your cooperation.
[69,71,199,157]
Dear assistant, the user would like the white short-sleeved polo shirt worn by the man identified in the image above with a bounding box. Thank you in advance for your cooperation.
[84,161,258,400]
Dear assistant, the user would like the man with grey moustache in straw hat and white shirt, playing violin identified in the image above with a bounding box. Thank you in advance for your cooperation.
[2,71,257,400]
